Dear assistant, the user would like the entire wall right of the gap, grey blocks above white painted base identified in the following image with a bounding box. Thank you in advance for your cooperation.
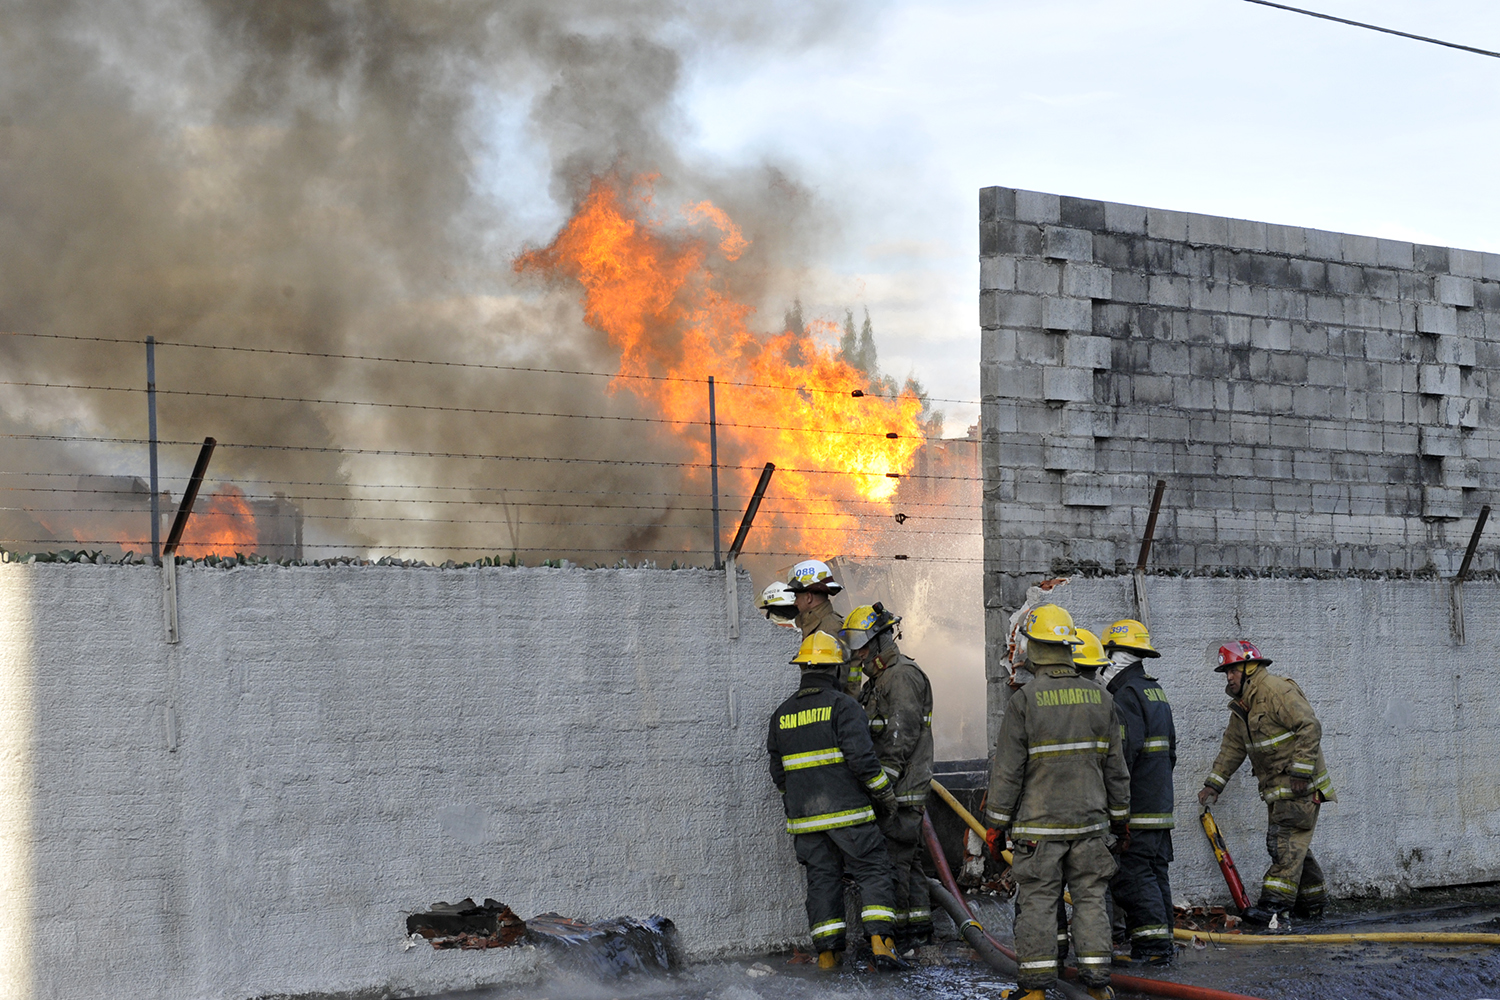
[980,187,1500,898]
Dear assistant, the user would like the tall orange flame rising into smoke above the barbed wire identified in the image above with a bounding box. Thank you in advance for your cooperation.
[516,178,924,555]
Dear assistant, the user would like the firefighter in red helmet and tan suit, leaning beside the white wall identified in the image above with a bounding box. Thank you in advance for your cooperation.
[1199,639,1338,930]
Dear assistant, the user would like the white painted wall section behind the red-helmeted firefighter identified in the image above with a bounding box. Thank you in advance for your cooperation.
[990,576,1500,903]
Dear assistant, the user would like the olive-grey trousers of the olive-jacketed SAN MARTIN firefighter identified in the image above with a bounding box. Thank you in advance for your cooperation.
[1011,837,1115,990]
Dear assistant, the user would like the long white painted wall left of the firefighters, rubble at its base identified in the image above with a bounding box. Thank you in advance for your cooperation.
[0,564,807,1000]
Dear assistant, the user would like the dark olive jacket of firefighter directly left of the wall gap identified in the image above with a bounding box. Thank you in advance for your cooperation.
[860,652,933,810]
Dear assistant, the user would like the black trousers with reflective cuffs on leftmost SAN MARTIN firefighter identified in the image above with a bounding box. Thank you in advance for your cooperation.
[795,823,896,952]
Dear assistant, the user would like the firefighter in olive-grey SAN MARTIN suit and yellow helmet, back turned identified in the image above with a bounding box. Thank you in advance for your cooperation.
[984,604,1130,1000]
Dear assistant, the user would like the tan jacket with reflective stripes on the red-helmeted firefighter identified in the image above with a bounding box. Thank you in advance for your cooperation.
[1203,664,1335,802]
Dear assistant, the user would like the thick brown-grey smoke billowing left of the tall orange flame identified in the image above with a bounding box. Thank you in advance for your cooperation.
[0,0,852,561]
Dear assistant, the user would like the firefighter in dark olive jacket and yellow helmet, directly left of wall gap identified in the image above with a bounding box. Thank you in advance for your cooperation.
[843,603,933,952]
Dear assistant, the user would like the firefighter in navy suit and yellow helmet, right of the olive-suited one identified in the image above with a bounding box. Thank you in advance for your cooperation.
[1101,618,1178,966]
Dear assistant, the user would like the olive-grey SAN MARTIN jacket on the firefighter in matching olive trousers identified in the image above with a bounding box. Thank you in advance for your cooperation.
[984,664,1130,841]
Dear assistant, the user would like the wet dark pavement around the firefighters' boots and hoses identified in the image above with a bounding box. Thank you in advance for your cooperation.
[426,886,1500,1000]
